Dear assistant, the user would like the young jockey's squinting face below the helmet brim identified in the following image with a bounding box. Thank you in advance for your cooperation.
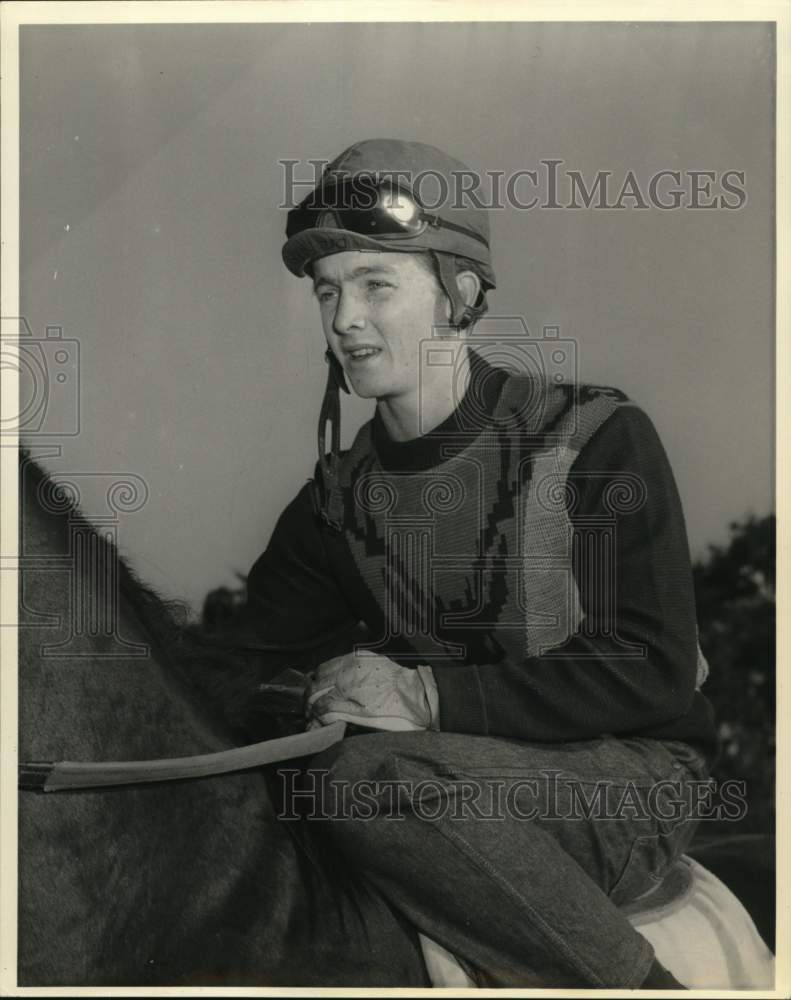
[313,250,449,407]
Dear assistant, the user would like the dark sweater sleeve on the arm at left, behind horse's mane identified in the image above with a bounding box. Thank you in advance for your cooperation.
[245,483,357,659]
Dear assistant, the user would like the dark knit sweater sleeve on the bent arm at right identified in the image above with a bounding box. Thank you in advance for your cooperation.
[432,406,705,741]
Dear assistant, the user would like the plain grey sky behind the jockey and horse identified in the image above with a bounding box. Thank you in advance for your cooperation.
[20,23,774,608]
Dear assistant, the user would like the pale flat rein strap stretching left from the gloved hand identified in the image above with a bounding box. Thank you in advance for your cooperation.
[19,722,346,792]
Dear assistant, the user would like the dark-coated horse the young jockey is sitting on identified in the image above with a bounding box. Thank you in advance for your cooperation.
[17,454,766,988]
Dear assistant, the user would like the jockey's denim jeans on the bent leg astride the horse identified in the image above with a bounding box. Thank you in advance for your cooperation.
[300,732,709,988]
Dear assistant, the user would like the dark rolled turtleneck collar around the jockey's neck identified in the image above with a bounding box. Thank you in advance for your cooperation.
[372,350,508,472]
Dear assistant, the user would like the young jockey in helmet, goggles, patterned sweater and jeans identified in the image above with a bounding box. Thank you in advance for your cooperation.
[248,139,716,989]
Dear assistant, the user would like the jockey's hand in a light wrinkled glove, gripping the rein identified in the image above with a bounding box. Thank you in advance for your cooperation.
[305,652,439,730]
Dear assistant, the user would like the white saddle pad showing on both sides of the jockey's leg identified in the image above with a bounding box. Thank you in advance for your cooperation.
[420,856,774,990]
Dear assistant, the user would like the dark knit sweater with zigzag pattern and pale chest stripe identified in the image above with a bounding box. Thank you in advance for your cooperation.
[248,356,716,759]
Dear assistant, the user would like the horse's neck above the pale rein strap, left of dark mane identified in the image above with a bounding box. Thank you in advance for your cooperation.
[19,458,228,760]
